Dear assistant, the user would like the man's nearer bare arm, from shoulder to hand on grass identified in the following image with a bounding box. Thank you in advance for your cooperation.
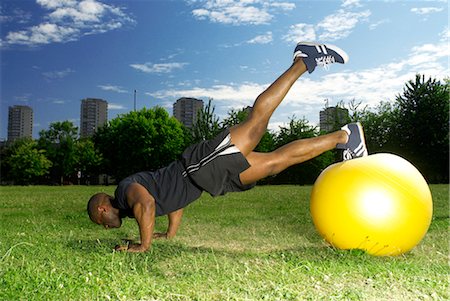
[116,183,156,252]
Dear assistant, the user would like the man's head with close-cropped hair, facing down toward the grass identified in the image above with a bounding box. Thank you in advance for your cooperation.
[87,192,122,229]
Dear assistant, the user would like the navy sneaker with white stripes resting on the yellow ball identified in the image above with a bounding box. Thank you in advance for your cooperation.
[336,122,368,161]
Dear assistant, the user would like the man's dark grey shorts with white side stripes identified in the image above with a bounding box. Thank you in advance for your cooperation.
[182,129,256,196]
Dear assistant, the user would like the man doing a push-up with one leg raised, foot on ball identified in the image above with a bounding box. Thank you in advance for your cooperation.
[88,43,367,252]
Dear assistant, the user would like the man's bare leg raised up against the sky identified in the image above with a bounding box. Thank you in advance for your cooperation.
[230,59,307,156]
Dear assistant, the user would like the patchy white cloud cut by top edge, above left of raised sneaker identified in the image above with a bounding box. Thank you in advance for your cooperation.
[192,0,295,25]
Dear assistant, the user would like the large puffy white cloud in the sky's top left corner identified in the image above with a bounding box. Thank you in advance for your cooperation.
[2,0,135,47]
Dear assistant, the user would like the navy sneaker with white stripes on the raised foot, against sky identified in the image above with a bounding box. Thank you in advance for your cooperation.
[294,42,348,73]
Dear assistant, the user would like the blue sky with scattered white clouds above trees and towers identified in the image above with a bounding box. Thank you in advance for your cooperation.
[0,0,450,138]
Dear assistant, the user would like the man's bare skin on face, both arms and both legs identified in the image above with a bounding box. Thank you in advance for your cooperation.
[89,59,348,252]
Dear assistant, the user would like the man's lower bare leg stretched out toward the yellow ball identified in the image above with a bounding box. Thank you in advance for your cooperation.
[240,130,349,185]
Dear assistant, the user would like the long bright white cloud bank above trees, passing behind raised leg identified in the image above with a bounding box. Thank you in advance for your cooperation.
[146,42,450,129]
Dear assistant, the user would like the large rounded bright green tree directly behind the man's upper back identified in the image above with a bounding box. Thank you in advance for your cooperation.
[94,107,186,180]
